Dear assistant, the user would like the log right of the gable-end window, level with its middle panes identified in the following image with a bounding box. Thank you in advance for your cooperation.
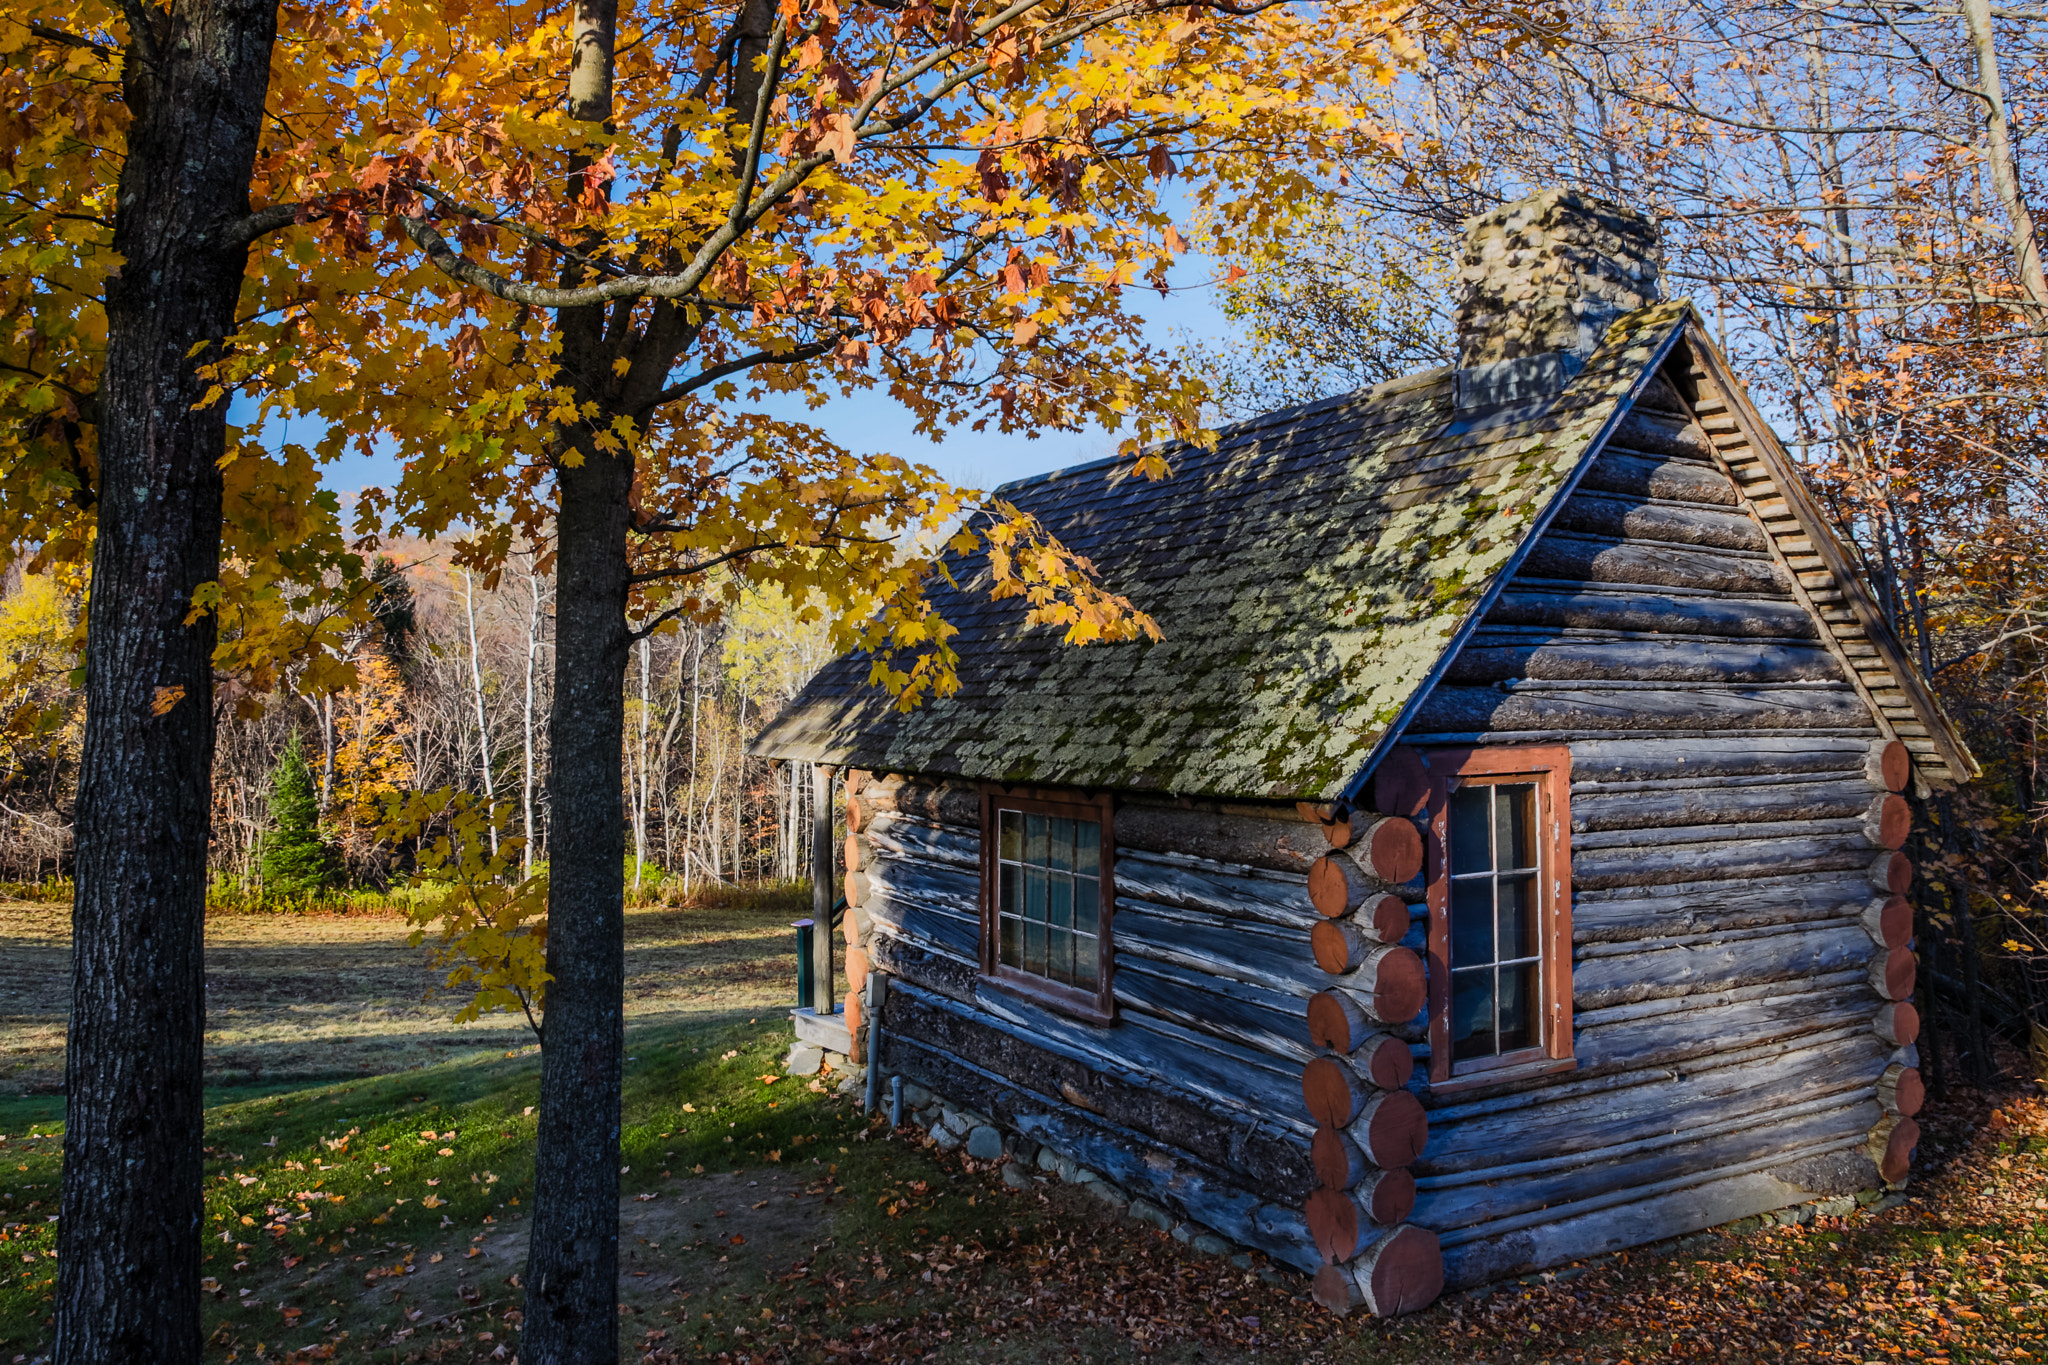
[1571,868,1870,943]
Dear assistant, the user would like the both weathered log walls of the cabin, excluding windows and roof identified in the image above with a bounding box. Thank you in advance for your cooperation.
[846,358,1919,1312]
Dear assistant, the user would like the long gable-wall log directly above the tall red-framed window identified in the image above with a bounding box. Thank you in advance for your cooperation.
[1415,684,1868,735]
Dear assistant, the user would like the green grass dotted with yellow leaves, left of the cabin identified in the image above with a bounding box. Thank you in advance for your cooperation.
[0,1017,1040,1359]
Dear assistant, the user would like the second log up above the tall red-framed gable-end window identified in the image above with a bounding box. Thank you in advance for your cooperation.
[1444,636,1843,684]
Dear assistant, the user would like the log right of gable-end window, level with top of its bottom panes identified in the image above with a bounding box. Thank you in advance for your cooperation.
[1571,919,1870,1011]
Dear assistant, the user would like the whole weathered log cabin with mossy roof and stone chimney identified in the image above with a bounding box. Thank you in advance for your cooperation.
[754,190,1976,1314]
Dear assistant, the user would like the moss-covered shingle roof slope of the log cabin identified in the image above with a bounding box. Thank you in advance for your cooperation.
[752,303,1690,800]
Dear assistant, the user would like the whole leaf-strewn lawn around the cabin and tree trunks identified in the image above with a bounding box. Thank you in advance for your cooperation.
[0,892,2048,1365]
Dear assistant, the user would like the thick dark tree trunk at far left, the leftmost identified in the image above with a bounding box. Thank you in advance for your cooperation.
[55,0,276,1365]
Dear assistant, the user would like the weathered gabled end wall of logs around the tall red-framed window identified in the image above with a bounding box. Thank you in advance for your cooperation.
[1380,360,1919,1285]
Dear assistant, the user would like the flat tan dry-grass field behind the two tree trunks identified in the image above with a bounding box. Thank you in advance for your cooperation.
[0,900,839,1095]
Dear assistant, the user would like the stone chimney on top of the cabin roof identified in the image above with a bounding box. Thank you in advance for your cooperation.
[1458,190,1663,407]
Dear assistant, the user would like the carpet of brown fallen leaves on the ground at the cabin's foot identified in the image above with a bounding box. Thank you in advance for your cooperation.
[663,1097,2048,1365]
